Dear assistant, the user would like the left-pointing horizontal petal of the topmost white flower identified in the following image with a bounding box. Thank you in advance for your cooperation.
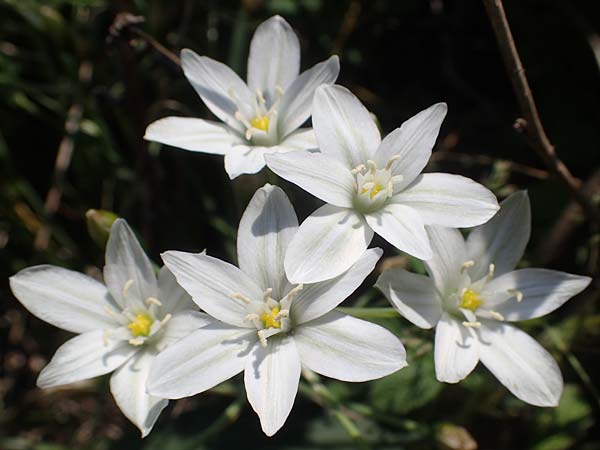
[144,117,243,155]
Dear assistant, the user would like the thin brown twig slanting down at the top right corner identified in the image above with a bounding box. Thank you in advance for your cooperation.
[483,0,600,223]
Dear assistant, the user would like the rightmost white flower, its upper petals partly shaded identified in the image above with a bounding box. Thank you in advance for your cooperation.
[376,192,591,406]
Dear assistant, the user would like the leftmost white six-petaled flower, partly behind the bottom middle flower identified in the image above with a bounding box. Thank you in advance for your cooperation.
[10,219,208,437]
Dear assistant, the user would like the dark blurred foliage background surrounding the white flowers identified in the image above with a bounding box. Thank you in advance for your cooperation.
[0,0,600,450]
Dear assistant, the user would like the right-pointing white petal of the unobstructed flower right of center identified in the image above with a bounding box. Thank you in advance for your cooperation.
[393,173,499,228]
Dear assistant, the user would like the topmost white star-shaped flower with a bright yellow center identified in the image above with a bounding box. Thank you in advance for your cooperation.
[145,16,340,179]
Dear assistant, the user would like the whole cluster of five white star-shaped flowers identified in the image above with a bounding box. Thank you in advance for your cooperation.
[10,16,590,436]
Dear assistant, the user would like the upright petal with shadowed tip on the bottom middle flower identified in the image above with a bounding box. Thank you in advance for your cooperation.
[237,184,298,298]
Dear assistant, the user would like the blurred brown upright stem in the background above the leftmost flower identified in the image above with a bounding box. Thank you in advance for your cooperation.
[33,61,92,251]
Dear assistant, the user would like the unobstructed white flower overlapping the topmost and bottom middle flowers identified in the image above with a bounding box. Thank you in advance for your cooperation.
[266,86,498,283]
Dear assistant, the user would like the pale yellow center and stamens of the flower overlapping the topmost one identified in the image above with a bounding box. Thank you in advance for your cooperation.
[352,158,402,212]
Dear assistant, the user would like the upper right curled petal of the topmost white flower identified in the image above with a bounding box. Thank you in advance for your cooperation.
[277,55,340,136]
